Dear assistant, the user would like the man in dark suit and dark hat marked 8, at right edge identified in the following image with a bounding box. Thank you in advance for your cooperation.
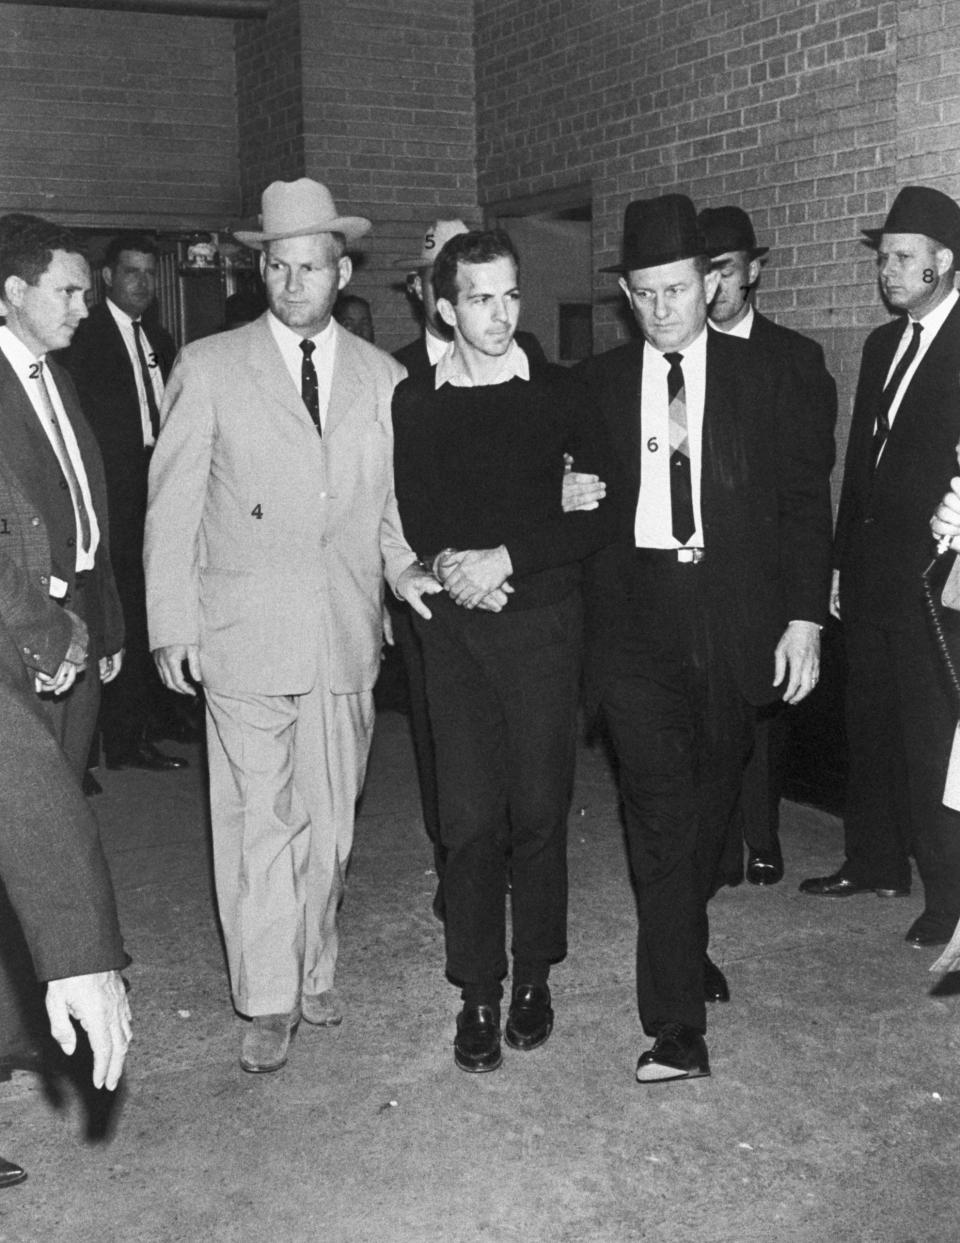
[800,185,960,947]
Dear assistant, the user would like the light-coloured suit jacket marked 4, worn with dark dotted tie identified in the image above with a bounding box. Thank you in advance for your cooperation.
[144,314,415,695]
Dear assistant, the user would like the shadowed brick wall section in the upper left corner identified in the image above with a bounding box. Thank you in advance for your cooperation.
[0,5,238,227]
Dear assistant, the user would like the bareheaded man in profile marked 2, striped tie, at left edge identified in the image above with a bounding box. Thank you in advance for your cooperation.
[0,215,123,776]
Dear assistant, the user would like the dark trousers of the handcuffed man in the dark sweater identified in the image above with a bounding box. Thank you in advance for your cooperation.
[415,593,582,1001]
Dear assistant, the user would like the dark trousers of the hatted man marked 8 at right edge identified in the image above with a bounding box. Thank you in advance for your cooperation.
[843,608,960,919]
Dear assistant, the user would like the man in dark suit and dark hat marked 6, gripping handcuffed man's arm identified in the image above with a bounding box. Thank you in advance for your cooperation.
[579,194,832,1083]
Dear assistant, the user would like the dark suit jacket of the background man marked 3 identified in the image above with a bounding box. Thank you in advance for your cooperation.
[58,302,177,544]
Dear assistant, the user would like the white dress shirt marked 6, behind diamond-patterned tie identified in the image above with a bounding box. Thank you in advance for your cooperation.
[633,328,708,548]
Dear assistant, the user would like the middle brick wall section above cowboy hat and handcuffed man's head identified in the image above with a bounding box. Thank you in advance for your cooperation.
[303,0,476,349]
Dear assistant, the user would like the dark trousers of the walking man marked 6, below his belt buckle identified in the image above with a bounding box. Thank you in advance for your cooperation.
[601,549,752,1035]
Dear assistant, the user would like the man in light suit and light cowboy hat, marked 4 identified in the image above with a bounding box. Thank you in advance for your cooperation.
[144,178,439,1071]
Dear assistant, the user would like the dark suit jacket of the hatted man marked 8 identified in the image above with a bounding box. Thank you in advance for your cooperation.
[833,302,960,628]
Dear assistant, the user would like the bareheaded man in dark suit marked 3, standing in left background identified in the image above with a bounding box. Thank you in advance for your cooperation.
[60,234,187,771]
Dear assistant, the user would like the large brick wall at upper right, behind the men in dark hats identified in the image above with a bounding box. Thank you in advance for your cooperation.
[476,0,960,474]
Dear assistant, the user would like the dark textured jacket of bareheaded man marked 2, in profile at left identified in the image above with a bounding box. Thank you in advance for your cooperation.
[0,354,123,674]
